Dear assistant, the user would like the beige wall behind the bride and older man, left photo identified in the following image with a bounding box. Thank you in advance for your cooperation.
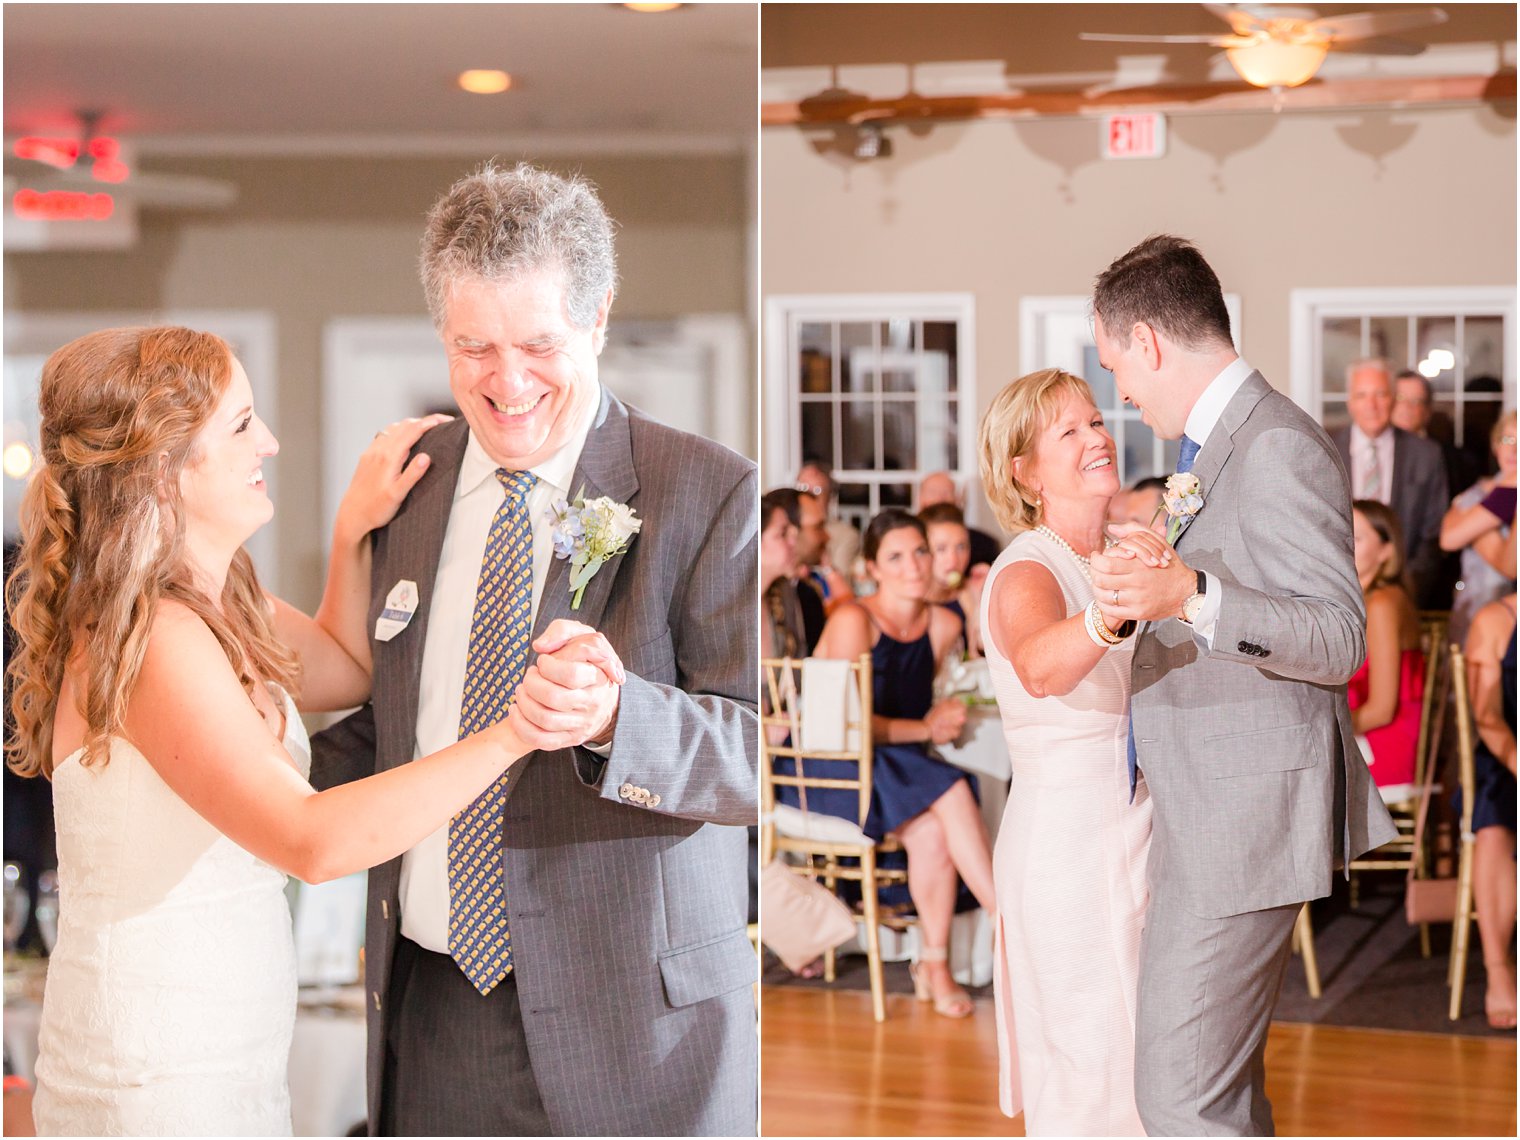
[5,155,754,606]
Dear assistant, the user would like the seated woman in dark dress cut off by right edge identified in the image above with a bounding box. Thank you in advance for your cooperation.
[1467,594,1515,1029]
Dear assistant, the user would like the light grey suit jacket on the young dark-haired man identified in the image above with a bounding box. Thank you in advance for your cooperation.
[1131,372,1394,918]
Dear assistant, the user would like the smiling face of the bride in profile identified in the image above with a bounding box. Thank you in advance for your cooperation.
[179,359,280,564]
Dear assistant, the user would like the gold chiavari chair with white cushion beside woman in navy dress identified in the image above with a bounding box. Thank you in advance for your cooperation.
[760,654,907,1021]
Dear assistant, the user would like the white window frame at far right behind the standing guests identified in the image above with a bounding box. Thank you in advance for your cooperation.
[1287,286,1515,423]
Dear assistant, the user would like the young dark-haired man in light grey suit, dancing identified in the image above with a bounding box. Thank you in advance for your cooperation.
[1093,236,1394,1135]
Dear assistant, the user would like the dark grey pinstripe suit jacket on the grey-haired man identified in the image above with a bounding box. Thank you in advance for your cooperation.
[312,389,758,1135]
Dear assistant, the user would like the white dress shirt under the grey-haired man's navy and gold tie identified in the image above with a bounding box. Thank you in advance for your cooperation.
[400,400,597,955]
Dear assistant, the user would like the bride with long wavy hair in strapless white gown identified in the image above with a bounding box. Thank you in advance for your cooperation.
[8,328,620,1135]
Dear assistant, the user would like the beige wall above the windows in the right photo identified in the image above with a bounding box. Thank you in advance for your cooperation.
[762,100,1515,525]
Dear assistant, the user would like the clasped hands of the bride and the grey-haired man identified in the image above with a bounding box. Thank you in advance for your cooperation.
[511,617,628,749]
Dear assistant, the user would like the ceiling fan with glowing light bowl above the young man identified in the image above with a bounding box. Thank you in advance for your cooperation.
[1081,5,1447,88]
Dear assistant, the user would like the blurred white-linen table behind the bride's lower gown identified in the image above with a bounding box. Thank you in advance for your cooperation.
[5,964,368,1135]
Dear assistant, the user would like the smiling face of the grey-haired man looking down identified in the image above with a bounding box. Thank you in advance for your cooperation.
[441,269,611,471]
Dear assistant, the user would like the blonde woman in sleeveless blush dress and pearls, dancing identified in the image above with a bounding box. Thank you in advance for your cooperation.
[980,369,1169,1135]
